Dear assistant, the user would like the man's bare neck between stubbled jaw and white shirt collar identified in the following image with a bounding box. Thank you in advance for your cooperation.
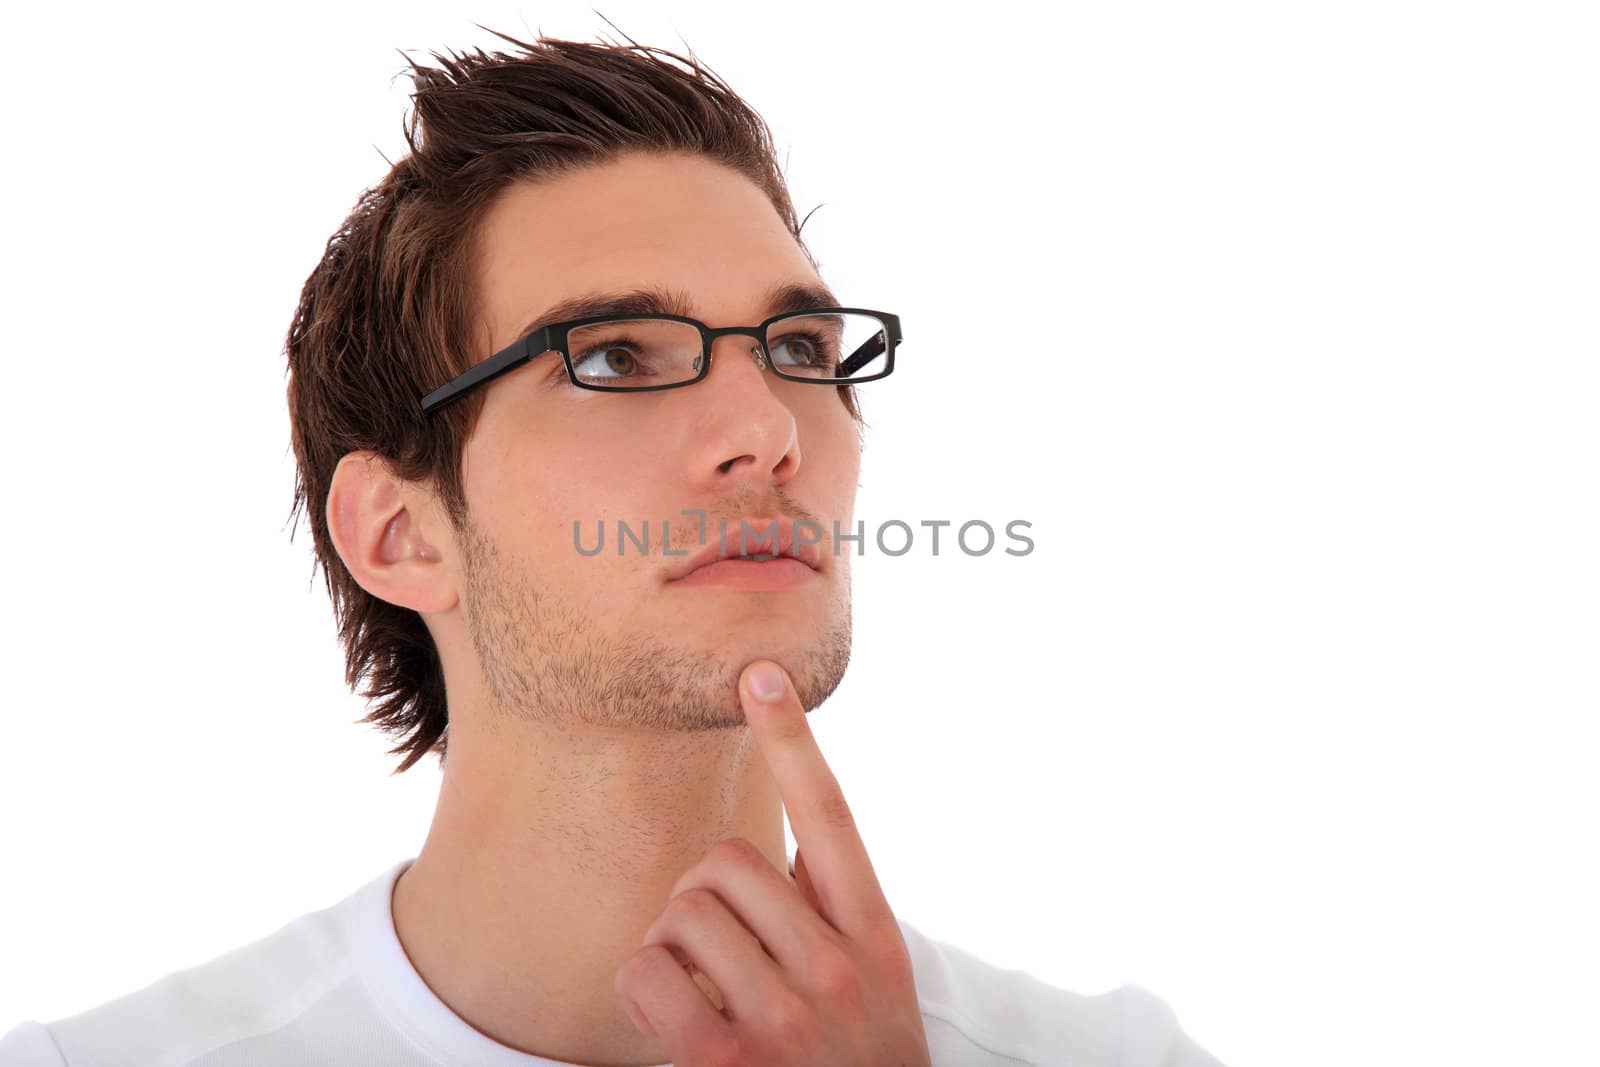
[392,718,789,1065]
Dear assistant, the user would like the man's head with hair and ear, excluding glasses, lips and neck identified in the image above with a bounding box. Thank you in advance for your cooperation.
[288,29,861,771]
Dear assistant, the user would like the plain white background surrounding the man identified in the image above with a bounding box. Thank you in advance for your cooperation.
[0,0,1600,1067]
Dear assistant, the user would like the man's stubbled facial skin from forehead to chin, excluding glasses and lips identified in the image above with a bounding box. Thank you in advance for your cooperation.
[446,154,861,729]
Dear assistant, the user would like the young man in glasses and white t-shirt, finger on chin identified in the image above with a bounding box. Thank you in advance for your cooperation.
[0,24,1216,1067]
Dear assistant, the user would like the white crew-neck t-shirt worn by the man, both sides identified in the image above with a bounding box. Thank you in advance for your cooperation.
[0,859,1221,1067]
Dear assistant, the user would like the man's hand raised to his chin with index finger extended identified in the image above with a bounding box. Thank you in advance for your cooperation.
[616,659,931,1067]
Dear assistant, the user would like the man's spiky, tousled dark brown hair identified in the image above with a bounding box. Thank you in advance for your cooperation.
[286,16,859,774]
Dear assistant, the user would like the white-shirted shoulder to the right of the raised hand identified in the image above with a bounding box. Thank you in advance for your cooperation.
[899,920,1221,1067]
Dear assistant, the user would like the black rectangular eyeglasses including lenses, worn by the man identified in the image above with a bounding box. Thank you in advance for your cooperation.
[422,307,901,414]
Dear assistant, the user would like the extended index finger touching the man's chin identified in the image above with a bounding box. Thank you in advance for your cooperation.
[739,659,894,936]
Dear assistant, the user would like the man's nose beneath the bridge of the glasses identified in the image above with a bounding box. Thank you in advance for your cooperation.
[685,334,800,494]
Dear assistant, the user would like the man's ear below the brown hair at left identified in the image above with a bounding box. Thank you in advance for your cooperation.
[328,451,459,614]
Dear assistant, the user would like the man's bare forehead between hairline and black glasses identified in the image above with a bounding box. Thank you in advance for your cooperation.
[478,154,816,350]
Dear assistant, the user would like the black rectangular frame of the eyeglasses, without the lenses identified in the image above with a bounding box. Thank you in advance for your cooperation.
[422,307,902,414]
